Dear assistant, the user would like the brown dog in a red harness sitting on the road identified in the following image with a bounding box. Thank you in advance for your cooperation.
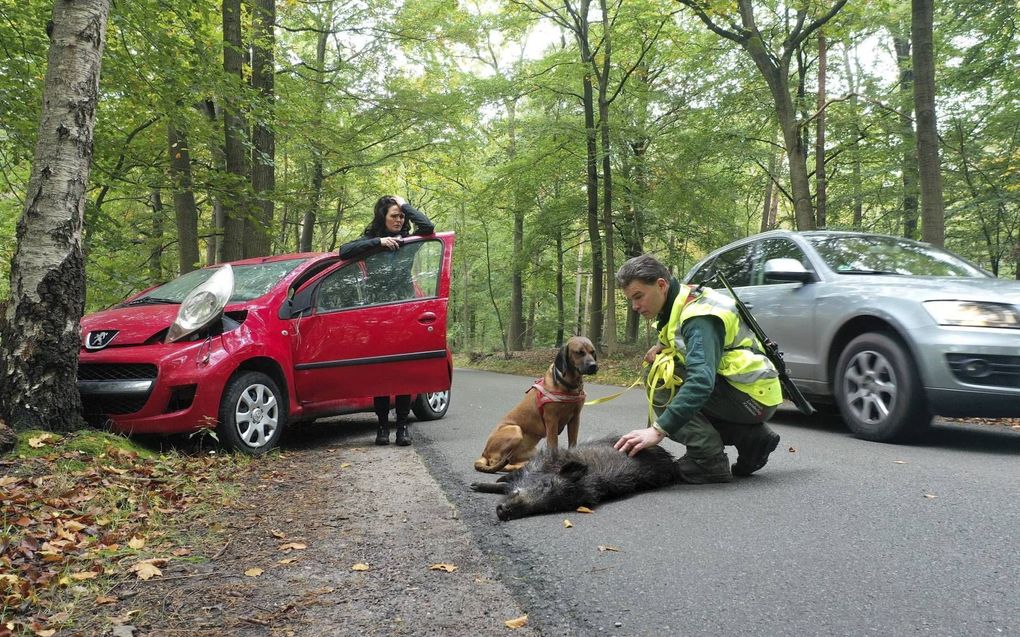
[474,336,599,473]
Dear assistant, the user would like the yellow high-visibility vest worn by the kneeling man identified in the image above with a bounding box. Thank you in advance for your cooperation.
[648,284,782,407]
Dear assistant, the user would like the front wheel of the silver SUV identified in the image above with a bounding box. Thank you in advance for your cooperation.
[833,332,931,442]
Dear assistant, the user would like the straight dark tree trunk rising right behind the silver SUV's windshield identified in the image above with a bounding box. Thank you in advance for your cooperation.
[910,0,946,246]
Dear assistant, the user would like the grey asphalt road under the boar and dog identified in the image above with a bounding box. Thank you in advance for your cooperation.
[414,370,1020,637]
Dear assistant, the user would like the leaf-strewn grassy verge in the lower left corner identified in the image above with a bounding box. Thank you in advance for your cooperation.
[0,430,255,637]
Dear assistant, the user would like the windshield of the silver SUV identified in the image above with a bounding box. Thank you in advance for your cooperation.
[805,234,988,278]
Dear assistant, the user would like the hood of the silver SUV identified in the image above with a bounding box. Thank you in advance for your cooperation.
[833,274,1020,306]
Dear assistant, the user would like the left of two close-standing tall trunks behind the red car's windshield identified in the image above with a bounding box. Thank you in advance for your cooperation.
[221,0,249,261]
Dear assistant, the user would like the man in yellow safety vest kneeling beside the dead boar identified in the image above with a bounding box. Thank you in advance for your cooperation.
[616,255,782,484]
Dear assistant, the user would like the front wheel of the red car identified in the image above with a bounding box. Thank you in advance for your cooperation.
[216,371,287,456]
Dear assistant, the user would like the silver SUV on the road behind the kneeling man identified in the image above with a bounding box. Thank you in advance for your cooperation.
[683,230,1020,441]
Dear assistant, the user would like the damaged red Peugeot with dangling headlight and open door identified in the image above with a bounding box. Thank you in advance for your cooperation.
[78,232,454,454]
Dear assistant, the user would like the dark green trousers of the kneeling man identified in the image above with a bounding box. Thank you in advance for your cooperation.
[652,376,776,459]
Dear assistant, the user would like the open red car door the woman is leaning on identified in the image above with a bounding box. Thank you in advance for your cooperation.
[292,232,454,412]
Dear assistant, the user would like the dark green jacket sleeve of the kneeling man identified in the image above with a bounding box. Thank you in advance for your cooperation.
[656,316,724,437]
